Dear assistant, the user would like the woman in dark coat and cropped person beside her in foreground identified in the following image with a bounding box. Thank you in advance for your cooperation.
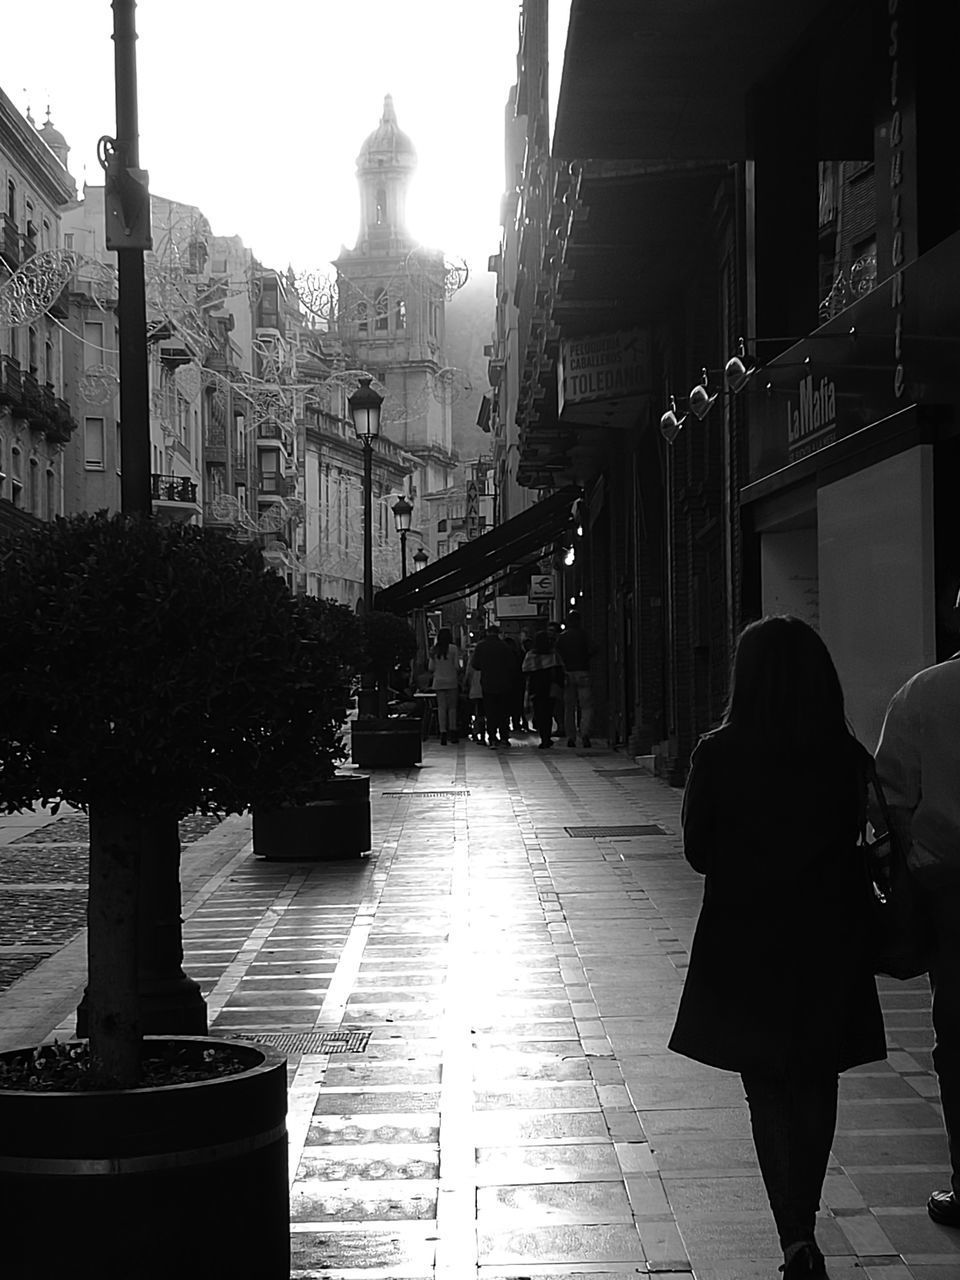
[669,617,960,1280]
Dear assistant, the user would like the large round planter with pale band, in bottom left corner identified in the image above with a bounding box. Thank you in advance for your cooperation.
[0,1036,289,1280]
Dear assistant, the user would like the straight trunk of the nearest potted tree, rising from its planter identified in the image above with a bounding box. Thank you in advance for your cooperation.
[87,805,141,1089]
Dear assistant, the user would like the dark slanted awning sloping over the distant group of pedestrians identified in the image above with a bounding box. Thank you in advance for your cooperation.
[374,485,580,613]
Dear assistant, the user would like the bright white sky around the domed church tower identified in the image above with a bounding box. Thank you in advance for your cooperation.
[0,0,570,279]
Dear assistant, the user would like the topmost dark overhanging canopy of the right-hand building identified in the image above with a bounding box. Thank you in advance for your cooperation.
[553,0,887,163]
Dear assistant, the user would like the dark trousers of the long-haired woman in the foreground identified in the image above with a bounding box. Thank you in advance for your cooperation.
[742,1069,837,1249]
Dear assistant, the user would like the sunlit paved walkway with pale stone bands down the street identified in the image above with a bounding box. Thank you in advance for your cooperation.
[0,737,960,1280]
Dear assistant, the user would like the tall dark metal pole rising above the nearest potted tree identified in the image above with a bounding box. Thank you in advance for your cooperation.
[113,0,152,516]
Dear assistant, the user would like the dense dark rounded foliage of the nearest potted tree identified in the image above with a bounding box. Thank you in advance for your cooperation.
[0,512,360,817]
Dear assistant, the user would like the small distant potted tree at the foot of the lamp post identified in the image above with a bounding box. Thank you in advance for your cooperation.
[351,609,421,769]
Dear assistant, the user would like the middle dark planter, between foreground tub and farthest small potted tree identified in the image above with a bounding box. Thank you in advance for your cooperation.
[253,774,370,861]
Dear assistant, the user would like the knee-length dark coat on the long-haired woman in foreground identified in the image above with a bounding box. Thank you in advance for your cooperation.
[669,727,886,1071]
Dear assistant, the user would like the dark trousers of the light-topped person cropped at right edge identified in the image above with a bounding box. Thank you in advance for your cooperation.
[923,886,960,1196]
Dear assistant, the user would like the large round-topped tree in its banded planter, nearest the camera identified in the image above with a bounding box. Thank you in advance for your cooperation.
[0,513,360,1280]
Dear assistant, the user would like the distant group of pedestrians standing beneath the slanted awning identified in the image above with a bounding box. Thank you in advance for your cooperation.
[429,611,593,749]
